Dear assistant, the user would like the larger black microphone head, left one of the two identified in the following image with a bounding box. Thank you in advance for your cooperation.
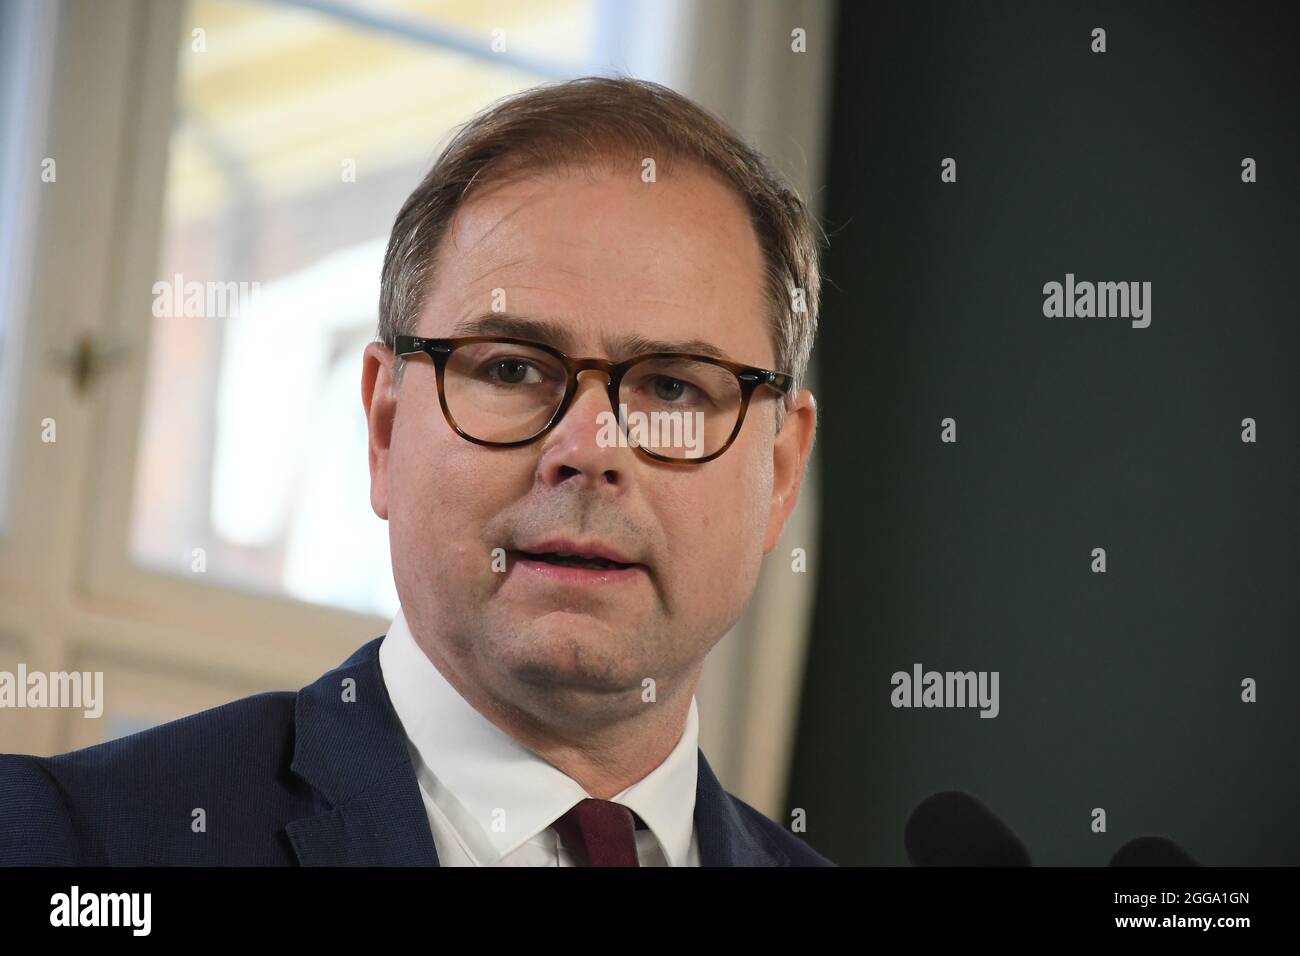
[902,790,1032,866]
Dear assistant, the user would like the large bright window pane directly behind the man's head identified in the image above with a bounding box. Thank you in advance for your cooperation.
[131,0,599,615]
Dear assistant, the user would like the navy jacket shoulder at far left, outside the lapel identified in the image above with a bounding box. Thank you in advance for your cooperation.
[0,692,301,865]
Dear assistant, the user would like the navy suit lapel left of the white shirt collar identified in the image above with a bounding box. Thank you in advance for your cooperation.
[285,637,438,866]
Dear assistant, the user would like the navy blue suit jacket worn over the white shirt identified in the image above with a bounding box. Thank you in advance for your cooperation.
[0,637,833,866]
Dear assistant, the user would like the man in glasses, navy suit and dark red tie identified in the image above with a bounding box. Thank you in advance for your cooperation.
[0,78,829,866]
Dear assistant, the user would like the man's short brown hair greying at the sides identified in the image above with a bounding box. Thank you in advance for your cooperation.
[378,77,824,429]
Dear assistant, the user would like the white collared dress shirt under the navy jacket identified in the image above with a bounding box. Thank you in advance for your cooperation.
[380,609,699,866]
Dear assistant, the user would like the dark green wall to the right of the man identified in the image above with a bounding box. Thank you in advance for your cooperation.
[788,3,1300,865]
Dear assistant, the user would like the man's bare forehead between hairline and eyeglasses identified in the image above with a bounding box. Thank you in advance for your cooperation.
[420,164,774,364]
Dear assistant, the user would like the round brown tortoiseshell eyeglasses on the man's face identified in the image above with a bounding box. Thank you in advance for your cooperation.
[395,336,794,464]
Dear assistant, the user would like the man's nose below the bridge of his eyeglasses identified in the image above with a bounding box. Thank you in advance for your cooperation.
[538,368,633,488]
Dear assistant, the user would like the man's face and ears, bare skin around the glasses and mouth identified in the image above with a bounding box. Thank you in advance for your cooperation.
[363,158,815,721]
